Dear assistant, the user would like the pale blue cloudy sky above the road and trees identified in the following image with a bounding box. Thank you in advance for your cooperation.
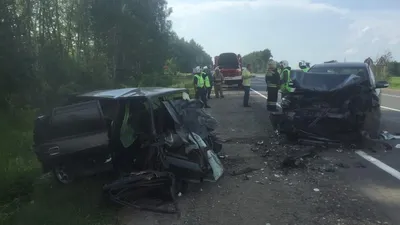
[168,0,400,65]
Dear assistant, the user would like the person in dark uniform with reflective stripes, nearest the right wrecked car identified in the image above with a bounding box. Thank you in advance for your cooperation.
[265,60,280,112]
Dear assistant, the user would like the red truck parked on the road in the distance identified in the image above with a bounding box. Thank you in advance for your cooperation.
[214,52,243,86]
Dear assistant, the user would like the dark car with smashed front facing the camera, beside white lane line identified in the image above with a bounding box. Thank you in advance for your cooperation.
[270,62,389,142]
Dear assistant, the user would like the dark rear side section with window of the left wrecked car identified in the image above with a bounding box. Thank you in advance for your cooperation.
[34,101,109,171]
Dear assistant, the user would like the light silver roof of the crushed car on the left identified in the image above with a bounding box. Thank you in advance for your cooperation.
[78,87,187,99]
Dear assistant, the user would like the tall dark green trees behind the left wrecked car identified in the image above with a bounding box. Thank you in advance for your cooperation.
[0,0,212,112]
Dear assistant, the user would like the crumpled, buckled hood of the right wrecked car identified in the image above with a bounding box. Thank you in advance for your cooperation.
[293,73,364,92]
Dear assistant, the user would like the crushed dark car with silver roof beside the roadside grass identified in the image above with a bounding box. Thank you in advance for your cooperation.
[34,87,223,184]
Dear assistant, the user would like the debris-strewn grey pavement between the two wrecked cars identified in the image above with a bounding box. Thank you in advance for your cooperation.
[120,91,391,225]
